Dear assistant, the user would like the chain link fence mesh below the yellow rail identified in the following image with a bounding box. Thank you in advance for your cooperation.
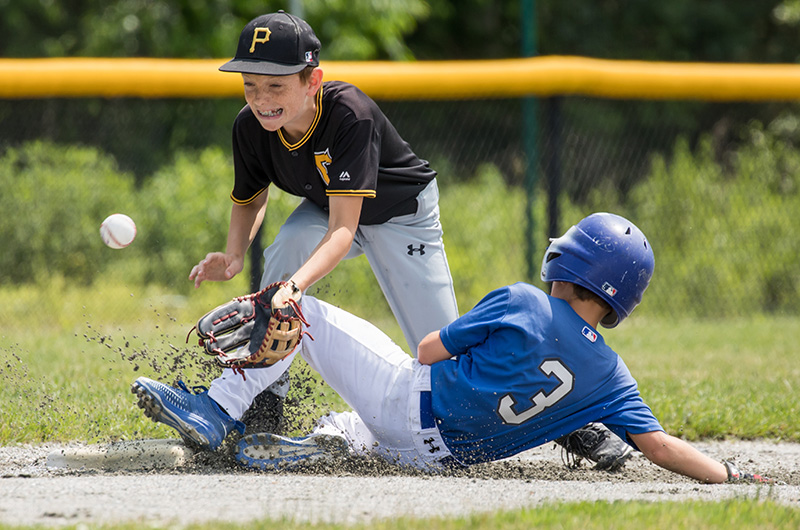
[0,93,800,317]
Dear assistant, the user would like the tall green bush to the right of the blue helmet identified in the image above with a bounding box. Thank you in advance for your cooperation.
[626,125,800,317]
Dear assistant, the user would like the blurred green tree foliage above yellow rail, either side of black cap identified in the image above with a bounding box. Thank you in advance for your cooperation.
[0,0,428,60]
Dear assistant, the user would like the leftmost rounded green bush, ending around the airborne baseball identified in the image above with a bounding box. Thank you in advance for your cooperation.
[0,138,136,284]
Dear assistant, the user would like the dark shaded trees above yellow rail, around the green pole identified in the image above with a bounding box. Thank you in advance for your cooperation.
[408,0,800,63]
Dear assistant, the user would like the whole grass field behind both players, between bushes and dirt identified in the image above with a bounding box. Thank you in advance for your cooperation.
[0,281,800,445]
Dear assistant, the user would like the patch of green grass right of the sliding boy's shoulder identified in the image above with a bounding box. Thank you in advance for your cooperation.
[605,316,800,442]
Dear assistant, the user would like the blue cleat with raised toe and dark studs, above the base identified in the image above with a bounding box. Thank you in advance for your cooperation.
[131,377,244,451]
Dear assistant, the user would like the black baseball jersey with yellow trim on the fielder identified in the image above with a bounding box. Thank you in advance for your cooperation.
[231,81,436,225]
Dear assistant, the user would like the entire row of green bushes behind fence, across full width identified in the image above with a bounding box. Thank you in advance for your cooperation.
[6,131,800,317]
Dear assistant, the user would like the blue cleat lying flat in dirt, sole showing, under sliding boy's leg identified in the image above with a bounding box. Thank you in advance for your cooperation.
[236,433,347,471]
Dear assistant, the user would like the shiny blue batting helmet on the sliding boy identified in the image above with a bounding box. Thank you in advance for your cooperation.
[542,213,655,328]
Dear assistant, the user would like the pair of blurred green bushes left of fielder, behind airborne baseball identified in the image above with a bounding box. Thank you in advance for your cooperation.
[0,142,306,292]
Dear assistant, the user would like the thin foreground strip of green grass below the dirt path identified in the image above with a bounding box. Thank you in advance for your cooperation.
[0,500,800,530]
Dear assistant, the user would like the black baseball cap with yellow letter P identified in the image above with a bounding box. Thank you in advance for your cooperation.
[219,11,320,75]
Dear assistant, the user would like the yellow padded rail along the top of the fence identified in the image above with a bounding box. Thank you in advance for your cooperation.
[0,56,800,101]
